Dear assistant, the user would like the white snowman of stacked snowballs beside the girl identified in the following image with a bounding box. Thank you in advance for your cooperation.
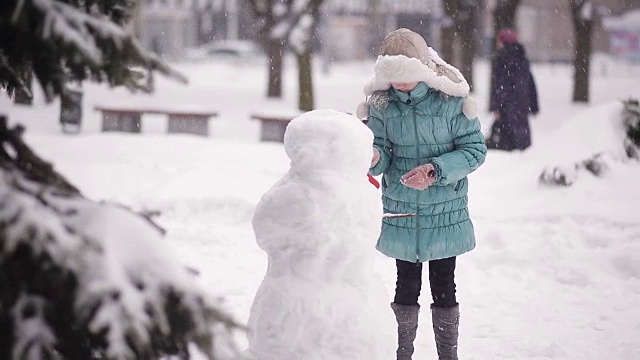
[248,110,396,360]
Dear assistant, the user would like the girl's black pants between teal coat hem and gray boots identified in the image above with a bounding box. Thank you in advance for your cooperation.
[393,256,458,308]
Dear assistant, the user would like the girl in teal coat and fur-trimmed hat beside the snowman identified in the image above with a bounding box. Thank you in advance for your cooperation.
[357,29,487,360]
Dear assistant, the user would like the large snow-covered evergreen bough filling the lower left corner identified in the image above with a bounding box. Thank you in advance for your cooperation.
[0,119,241,360]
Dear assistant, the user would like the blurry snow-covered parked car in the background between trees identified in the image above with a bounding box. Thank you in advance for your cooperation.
[185,40,267,64]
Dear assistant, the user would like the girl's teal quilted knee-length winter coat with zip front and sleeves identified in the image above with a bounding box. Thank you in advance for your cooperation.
[367,82,487,262]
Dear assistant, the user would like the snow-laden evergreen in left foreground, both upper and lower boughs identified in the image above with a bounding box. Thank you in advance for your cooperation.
[0,0,241,360]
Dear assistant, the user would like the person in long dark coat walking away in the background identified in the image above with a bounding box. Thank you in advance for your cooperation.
[486,29,539,151]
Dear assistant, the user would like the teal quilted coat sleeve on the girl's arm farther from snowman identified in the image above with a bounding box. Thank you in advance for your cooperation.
[431,109,487,186]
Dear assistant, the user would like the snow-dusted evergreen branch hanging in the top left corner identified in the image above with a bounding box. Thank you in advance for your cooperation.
[0,0,187,100]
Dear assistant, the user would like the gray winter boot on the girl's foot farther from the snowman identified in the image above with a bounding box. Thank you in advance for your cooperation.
[431,305,460,360]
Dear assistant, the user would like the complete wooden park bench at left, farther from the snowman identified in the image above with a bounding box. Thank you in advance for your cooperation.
[95,106,218,136]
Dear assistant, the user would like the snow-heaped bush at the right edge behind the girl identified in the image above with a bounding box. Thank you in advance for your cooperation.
[539,99,640,186]
